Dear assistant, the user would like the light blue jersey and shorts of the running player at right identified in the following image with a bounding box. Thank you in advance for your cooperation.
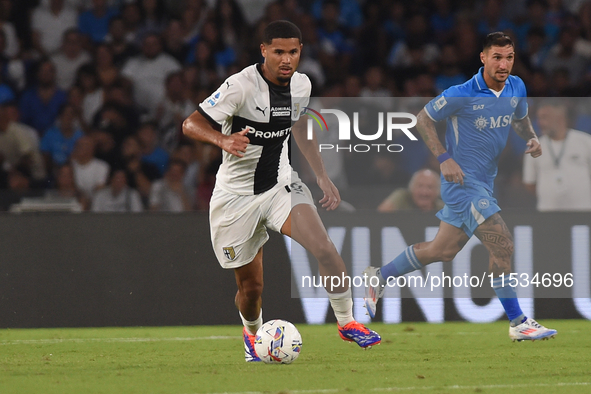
[425,68,527,236]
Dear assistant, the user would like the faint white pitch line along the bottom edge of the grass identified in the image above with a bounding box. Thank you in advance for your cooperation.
[202,382,591,394]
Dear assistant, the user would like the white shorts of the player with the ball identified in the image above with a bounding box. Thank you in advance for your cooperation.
[209,176,315,268]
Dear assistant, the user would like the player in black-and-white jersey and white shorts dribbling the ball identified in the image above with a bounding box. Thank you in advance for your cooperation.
[183,21,381,361]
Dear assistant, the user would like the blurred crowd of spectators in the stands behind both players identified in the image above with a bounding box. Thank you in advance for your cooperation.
[0,0,591,212]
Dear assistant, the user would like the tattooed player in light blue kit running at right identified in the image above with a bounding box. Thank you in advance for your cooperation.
[364,32,556,341]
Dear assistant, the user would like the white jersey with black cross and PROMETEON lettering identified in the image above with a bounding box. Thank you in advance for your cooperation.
[197,64,312,195]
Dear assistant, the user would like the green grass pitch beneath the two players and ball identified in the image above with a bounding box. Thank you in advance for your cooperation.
[0,320,591,394]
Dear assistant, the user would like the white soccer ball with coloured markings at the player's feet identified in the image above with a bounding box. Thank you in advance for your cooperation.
[254,320,302,364]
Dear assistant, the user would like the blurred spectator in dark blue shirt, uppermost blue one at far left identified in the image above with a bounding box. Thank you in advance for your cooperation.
[20,59,67,135]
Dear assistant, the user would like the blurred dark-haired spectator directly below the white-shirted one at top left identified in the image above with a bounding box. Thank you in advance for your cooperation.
[51,29,91,90]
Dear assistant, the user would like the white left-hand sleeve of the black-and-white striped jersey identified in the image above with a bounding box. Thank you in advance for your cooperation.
[197,75,246,124]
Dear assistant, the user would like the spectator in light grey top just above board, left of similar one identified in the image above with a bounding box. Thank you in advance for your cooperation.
[91,169,144,212]
